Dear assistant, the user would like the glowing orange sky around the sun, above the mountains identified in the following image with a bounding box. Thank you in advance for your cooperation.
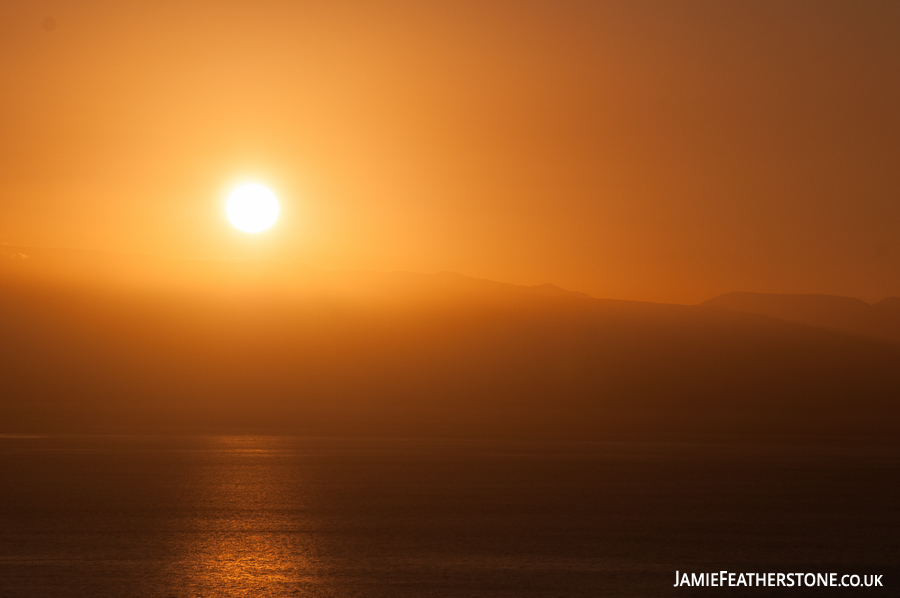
[0,0,900,303]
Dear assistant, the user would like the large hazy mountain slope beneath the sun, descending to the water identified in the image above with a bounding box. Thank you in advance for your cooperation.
[0,248,900,438]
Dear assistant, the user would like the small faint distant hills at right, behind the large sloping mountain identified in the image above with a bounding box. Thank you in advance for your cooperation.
[701,293,900,341]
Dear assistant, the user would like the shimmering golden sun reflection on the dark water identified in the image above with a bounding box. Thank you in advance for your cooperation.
[172,437,321,596]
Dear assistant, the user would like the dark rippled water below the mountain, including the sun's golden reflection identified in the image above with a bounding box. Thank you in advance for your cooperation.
[0,436,900,597]
